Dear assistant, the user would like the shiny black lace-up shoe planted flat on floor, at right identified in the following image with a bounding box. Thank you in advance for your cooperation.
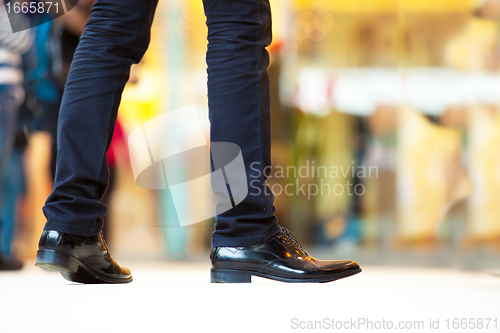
[210,228,361,283]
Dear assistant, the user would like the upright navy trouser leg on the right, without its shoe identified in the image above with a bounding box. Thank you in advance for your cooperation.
[203,0,280,247]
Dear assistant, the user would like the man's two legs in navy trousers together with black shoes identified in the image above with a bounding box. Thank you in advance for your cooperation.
[36,0,361,283]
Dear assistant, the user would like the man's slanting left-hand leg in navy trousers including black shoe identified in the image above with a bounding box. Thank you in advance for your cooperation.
[37,0,157,283]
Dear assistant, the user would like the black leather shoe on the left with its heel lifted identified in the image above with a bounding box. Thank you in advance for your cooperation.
[35,230,132,283]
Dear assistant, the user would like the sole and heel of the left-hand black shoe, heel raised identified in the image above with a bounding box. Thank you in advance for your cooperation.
[35,249,132,284]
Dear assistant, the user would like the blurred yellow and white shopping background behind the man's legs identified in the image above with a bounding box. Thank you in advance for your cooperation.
[0,0,500,268]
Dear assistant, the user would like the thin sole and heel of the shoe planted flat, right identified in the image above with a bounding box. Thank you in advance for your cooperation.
[210,268,362,283]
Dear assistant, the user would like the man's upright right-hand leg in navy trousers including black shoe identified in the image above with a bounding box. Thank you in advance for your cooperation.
[204,0,361,283]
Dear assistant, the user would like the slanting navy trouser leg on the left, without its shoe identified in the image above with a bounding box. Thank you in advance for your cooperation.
[43,0,157,236]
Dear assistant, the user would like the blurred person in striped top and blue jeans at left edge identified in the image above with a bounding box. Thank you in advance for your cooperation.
[0,1,32,270]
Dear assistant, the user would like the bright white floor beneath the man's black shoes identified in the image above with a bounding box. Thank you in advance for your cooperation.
[0,262,500,333]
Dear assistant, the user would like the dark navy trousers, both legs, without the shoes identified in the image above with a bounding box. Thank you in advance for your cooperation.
[43,0,280,247]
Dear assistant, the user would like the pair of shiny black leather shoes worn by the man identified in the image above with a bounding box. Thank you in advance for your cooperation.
[36,228,361,283]
